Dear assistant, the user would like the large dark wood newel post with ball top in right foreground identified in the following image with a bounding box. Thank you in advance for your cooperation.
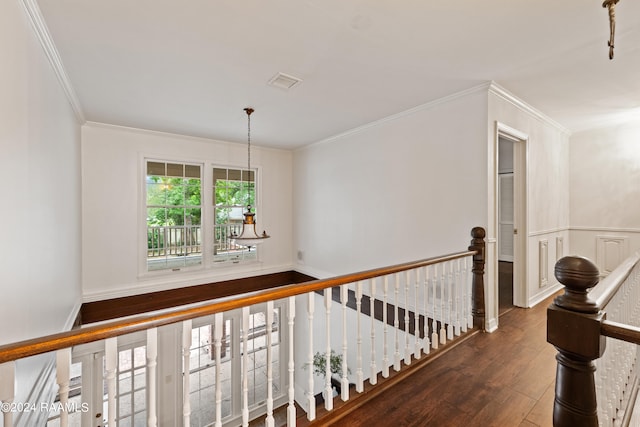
[547,256,606,427]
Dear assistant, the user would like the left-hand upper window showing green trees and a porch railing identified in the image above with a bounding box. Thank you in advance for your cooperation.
[146,161,202,271]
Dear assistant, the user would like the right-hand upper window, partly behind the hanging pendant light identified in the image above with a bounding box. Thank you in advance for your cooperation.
[213,167,256,262]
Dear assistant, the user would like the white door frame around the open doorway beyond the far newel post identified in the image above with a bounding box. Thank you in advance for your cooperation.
[485,121,529,331]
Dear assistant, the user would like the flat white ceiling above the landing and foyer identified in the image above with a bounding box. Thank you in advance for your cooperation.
[37,0,640,148]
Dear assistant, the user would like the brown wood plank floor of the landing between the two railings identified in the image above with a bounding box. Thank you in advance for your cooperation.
[312,292,556,427]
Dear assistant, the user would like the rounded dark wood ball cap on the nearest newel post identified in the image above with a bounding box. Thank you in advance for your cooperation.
[554,256,600,313]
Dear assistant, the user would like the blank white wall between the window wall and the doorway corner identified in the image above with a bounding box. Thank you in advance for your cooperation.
[293,88,487,277]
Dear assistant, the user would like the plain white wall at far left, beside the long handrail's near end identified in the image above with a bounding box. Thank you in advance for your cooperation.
[0,1,81,425]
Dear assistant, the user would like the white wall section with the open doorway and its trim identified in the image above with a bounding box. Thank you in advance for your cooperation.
[487,86,569,322]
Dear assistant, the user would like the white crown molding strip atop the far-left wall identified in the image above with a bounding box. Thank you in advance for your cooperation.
[20,0,86,125]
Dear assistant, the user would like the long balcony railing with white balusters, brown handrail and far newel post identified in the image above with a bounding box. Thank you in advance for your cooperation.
[0,227,485,427]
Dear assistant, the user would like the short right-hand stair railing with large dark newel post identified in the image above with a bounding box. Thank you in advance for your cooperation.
[547,252,640,427]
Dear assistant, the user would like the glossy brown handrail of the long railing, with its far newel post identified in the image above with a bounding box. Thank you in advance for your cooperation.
[0,227,485,363]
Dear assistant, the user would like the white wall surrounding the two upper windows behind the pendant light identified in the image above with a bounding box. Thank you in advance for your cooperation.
[82,123,292,301]
